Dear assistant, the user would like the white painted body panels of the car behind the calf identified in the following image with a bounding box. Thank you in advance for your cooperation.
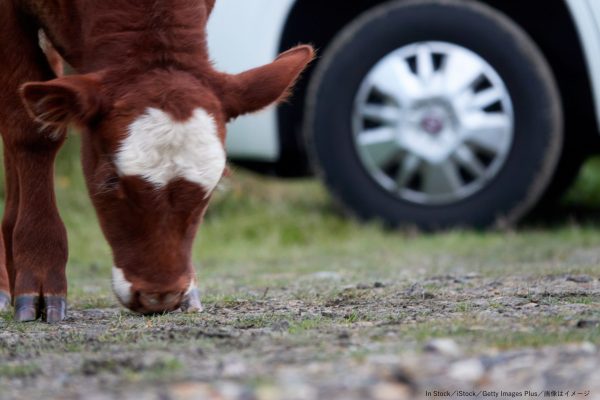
[208,0,600,161]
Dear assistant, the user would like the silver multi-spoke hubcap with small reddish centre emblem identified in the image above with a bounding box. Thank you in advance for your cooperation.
[353,42,514,205]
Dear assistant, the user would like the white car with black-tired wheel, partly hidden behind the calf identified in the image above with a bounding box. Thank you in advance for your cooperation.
[208,0,600,230]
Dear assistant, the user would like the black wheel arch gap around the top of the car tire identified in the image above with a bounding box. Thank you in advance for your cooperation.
[277,0,600,175]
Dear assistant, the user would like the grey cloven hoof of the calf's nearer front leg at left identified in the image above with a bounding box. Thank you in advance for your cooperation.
[15,295,67,324]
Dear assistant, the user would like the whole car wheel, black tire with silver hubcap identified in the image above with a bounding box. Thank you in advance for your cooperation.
[304,0,563,230]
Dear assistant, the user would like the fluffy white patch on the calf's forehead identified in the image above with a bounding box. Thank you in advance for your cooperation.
[115,108,225,193]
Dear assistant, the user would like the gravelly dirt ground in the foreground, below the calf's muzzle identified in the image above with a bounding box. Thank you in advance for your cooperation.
[0,271,600,400]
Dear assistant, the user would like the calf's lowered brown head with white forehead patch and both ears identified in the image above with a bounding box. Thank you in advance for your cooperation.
[21,46,313,313]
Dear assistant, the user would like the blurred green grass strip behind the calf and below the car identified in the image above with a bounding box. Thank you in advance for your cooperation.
[0,135,600,296]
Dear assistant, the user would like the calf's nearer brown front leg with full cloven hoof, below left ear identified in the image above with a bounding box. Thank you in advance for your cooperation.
[9,139,68,322]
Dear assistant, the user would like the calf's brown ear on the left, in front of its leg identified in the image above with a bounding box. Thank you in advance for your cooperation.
[20,74,102,129]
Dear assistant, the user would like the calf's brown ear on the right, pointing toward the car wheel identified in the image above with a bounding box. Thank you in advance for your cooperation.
[223,46,315,119]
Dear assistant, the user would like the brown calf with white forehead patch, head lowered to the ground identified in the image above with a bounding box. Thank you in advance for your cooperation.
[0,0,313,322]
